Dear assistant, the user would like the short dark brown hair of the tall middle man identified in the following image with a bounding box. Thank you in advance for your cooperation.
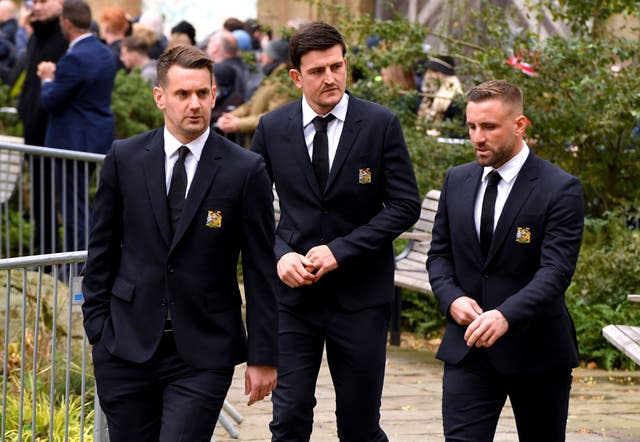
[289,22,347,70]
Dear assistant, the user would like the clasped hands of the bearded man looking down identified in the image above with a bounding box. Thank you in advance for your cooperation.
[449,296,509,347]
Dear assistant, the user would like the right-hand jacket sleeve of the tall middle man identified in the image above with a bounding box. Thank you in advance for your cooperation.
[328,115,420,263]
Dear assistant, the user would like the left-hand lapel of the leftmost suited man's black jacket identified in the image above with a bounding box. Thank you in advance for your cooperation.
[144,130,171,246]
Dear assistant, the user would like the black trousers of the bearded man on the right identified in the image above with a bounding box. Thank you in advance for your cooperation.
[442,348,572,442]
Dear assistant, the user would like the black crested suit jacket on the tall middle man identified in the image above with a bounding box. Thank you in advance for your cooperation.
[252,95,420,310]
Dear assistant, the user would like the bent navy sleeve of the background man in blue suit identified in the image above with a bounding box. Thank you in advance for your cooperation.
[41,54,82,114]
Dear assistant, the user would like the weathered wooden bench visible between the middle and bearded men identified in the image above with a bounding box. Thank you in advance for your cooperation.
[389,190,440,345]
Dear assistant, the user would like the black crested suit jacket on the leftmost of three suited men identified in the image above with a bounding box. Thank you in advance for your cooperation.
[83,129,277,369]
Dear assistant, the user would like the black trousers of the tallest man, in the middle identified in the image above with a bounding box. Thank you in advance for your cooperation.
[270,303,390,442]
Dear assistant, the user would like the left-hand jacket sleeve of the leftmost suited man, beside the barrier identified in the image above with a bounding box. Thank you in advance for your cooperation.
[82,143,122,344]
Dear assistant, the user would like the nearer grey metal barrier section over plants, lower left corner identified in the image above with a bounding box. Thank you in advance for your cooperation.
[0,251,96,442]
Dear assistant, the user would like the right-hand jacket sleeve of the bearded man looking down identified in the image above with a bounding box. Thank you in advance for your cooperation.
[497,177,584,327]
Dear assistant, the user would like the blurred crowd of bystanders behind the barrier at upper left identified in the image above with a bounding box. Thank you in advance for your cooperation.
[0,0,293,253]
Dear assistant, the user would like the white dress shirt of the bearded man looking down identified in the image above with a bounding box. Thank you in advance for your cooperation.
[473,141,529,239]
